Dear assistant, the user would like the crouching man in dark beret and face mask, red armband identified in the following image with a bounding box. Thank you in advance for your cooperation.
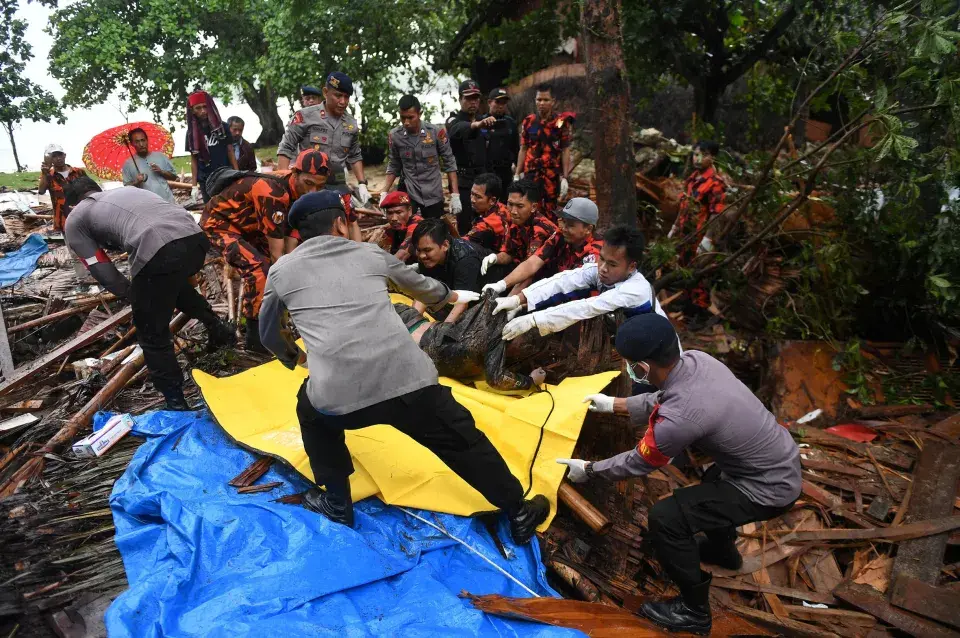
[557,314,801,635]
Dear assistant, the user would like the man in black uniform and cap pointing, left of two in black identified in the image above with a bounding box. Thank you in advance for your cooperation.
[447,80,496,235]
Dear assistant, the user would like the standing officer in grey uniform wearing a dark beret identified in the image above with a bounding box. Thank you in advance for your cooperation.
[277,71,370,206]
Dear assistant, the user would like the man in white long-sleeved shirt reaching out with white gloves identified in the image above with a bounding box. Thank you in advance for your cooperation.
[493,226,666,341]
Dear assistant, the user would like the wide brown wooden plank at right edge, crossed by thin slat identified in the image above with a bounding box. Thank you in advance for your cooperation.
[893,444,960,585]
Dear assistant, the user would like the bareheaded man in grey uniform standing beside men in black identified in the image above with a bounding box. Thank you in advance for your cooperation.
[380,95,463,217]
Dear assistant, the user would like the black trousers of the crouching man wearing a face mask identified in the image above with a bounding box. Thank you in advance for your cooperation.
[649,466,793,592]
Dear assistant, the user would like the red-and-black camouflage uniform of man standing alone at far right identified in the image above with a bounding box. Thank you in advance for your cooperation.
[672,166,727,308]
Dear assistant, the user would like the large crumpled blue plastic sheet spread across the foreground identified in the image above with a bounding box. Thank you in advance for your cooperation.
[108,412,583,638]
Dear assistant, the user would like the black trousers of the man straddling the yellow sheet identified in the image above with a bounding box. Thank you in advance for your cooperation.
[297,381,523,516]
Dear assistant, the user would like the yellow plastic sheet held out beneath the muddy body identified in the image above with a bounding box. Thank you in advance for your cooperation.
[193,361,618,530]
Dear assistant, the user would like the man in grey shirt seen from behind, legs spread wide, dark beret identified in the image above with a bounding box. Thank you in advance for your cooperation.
[260,191,550,544]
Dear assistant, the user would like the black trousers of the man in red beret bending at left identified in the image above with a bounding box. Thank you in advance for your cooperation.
[130,233,218,395]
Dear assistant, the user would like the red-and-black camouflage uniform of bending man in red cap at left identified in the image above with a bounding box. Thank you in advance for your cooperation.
[200,173,297,319]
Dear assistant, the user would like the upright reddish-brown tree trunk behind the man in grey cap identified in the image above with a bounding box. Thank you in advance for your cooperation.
[581,0,637,228]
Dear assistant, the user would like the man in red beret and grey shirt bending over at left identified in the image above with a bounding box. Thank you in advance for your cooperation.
[64,177,234,410]
